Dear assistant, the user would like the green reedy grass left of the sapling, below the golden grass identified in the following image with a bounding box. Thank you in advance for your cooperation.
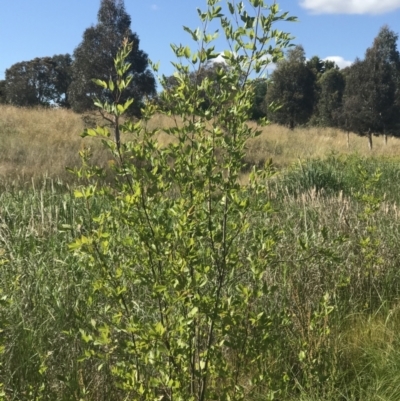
[0,180,106,401]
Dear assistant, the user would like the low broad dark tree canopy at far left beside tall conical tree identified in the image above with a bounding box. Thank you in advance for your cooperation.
[5,54,72,107]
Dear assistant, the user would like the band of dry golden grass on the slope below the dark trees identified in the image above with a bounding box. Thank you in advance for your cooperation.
[0,105,400,179]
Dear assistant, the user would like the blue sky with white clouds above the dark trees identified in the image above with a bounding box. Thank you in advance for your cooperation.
[0,0,400,79]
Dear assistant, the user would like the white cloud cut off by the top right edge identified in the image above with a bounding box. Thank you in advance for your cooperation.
[300,0,400,14]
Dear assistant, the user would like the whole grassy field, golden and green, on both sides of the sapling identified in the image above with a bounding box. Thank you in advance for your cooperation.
[0,106,400,401]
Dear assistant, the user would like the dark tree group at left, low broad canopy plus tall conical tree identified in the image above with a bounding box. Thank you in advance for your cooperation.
[0,0,156,113]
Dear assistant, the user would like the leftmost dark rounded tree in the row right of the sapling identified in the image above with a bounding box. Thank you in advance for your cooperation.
[266,46,315,129]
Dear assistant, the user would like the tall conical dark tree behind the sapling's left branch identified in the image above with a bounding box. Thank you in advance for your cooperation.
[68,0,155,114]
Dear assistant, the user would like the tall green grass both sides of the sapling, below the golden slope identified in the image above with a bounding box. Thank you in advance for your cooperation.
[0,158,400,400]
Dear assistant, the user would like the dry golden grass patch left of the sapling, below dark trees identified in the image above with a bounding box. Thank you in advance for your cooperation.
[0,106,106,181]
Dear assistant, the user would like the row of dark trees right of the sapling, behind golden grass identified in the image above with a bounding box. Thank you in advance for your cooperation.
[265,26,400,148]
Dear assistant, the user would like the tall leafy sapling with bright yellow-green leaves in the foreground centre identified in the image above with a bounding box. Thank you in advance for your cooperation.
[70,0,291,400]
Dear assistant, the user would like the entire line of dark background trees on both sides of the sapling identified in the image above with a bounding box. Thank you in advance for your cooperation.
[0,0,400,147]
